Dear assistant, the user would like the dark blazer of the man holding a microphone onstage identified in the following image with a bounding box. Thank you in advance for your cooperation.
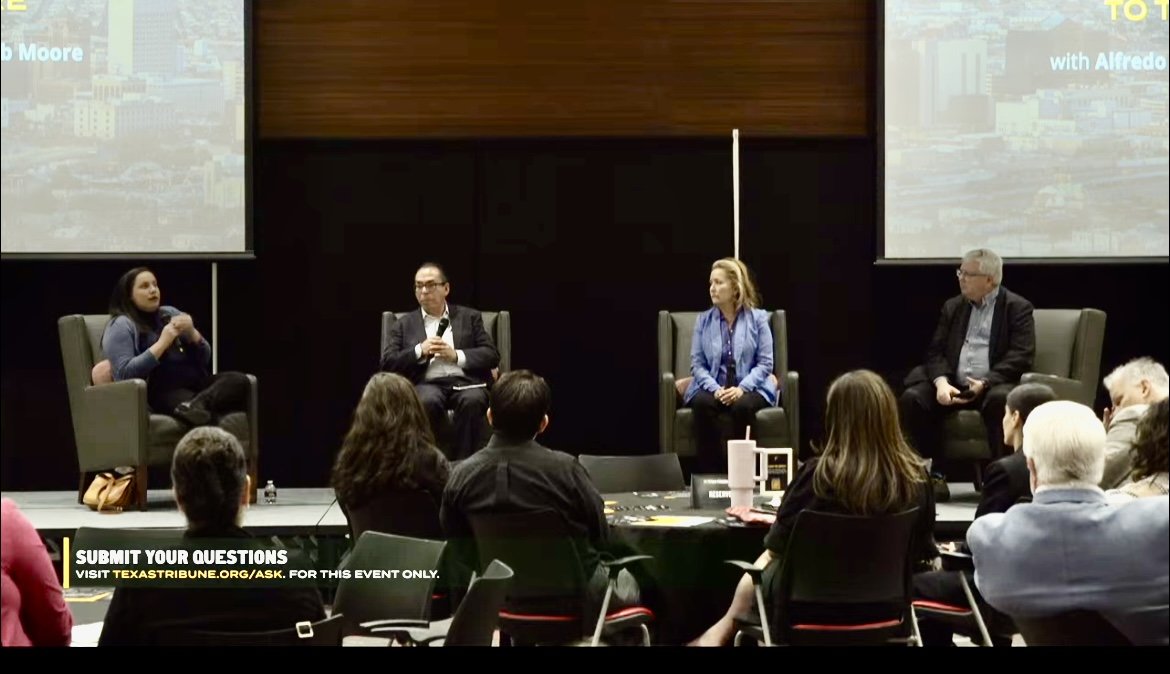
[381,304,500,386]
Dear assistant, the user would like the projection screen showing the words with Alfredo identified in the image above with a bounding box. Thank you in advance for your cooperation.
[878,0,1170,260]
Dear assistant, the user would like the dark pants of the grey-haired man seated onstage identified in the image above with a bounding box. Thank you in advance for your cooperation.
[899,381,1013,459]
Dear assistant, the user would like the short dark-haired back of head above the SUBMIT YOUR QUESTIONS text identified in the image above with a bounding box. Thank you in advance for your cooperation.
[171,426,248,531]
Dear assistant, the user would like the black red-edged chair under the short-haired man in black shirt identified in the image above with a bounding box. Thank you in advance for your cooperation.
[470,509,654,646]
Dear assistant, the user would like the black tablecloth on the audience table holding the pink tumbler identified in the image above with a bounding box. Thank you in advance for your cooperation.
[604,491,768,645]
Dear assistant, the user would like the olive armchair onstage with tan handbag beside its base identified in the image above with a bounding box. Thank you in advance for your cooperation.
[57,314,260,510]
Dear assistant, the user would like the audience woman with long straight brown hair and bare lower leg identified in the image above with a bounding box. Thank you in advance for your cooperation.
[693,370,937,646]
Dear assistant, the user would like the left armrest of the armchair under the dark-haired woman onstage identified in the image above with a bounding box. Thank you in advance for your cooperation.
[74,379,149,470]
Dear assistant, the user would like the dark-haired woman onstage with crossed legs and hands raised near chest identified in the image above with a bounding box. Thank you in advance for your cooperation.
[102,267,249,426]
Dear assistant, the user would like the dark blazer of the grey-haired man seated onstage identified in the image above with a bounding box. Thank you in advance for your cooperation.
[906,286,1035,386]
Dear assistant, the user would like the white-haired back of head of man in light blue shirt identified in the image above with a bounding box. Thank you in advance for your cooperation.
[1024,400,1106,488]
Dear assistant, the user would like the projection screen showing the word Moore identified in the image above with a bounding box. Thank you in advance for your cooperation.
[0,0,252,257]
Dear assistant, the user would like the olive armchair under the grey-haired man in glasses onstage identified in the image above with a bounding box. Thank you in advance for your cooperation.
[942,309,1106,489]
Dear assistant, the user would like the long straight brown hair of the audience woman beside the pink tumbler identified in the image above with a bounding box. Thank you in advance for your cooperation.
[813,370,925,515]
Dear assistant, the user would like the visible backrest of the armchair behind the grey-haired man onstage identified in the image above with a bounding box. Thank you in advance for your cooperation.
[1032,309,1106,405]
